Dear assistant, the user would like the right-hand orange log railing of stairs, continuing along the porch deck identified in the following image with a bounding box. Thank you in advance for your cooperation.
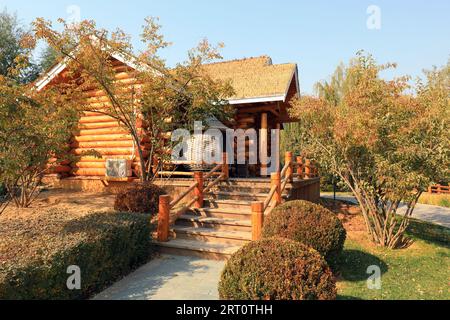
[252,151,319,240]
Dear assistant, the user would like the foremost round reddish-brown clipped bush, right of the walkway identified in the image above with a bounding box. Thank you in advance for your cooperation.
[219,238,336,300]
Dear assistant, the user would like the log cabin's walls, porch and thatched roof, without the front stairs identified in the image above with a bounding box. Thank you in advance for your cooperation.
[36,56,300,181]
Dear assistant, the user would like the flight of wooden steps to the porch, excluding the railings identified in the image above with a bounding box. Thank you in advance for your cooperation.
[158,179,270,259]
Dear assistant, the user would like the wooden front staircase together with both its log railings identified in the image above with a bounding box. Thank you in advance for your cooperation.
[157,152,317,259]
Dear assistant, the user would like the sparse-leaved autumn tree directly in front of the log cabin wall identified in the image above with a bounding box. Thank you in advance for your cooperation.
[34,18,232,181]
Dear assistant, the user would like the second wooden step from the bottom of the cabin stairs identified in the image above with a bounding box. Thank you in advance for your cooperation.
[171,225,252,246]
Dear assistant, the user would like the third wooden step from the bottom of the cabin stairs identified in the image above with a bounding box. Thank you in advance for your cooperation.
[176,214,252,232]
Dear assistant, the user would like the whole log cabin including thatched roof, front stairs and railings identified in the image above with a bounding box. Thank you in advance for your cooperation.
[36,52,320,259]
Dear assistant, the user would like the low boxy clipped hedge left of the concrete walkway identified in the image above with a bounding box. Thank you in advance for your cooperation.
[0,211,152,299]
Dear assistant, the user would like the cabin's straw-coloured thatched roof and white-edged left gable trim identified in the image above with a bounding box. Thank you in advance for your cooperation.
[35,54,300,104]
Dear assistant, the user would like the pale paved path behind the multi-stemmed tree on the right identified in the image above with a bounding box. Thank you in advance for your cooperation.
[320,193,450,228]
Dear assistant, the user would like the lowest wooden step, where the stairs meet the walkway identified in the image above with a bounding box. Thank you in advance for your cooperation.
[156,239,241,260]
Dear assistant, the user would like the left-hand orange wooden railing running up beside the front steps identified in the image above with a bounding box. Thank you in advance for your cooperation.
[157,153,229,242]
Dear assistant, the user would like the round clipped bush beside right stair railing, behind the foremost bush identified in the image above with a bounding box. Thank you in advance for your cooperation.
[262,200,346,263]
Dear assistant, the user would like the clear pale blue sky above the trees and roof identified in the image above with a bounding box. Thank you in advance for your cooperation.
[0,0,450,93]
